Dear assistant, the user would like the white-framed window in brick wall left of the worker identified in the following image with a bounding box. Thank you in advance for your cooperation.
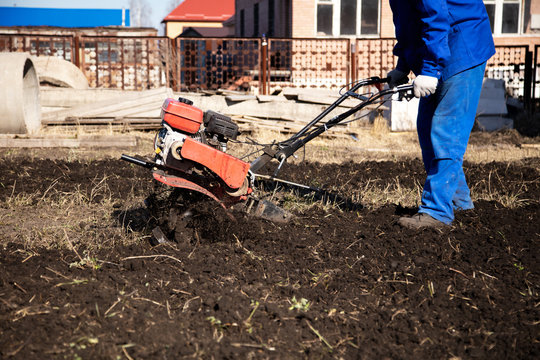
[317,0,381,36]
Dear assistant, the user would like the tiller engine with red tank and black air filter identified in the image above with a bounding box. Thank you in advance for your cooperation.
[154,98,239,167]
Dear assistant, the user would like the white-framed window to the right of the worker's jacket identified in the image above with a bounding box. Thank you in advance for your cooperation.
[484,0,521,35]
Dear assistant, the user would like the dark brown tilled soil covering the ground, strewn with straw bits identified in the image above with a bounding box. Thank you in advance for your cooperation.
[0,158,540,359]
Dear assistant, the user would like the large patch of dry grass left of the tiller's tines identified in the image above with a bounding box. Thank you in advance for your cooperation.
[0,177,150,251]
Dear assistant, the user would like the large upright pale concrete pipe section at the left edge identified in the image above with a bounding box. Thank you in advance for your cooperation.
[0,53,41,134]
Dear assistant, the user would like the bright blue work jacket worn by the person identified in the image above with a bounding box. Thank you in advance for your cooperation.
[390,0,495,81]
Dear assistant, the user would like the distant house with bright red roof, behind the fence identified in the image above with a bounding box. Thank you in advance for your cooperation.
[162,0,235,39]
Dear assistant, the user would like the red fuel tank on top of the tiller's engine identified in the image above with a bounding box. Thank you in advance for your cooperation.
[161,98,204,134]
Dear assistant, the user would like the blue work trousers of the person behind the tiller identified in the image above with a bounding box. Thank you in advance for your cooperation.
[417,63,486,224]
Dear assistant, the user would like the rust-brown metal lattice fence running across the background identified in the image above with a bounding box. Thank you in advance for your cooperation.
[0,34,540,105]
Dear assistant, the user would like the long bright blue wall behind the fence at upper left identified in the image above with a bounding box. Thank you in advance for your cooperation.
[0,7,129,27]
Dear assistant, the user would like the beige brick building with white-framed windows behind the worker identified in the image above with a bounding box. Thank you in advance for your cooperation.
[235,0,540,42]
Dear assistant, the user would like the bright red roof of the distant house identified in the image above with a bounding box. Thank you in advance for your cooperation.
[163,0,234,22]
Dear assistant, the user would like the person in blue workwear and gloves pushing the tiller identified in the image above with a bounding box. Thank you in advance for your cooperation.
[388,0,495,229]
